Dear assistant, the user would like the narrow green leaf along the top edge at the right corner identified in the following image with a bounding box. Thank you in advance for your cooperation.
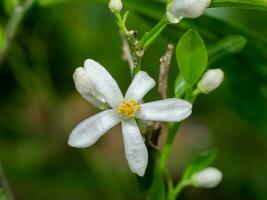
[214,0,267,10]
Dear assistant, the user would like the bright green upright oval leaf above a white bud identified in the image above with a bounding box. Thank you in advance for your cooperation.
[176,30,208,86]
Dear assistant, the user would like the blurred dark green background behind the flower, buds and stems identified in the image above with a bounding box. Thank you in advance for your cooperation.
[0,0,267,200]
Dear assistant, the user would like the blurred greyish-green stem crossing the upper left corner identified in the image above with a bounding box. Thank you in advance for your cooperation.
[0,0,34,64]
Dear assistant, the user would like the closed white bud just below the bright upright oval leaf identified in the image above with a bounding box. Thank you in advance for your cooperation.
[197,69,224,94]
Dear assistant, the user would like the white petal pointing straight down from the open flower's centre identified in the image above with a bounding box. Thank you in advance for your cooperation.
[122,120,148,176]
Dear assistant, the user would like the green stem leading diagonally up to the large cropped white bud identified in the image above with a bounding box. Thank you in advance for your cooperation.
[138,15,168,49]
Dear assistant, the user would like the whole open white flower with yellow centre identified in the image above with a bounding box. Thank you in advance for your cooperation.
[68,59,192,176]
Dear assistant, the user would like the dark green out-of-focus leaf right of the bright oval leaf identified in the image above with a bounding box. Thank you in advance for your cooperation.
[208,35,247,64]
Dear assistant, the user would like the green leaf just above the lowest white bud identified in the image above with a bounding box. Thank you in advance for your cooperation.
[183,150,217,181]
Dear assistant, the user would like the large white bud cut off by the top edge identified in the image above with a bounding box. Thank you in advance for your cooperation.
[167,0,211,23]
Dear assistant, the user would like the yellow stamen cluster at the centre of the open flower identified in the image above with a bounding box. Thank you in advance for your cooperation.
[118,99,141,119]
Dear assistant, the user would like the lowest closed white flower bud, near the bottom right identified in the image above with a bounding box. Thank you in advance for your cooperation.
[192,167,223,188]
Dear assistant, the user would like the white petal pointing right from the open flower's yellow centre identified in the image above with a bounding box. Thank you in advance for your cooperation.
[135,98,192,122]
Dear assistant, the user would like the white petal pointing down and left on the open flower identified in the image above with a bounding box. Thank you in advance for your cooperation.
[68,110,120,148]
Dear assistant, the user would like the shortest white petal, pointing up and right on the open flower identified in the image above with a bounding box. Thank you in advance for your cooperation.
[125,71,156,102]
